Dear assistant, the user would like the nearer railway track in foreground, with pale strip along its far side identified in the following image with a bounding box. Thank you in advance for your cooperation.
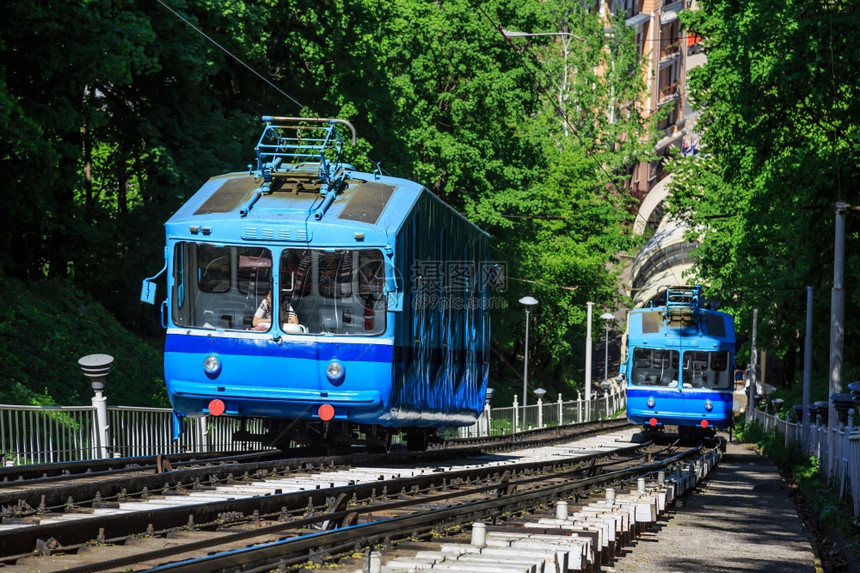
[0,418,691,571]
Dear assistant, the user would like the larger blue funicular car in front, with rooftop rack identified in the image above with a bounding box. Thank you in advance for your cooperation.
[148,118,491,442]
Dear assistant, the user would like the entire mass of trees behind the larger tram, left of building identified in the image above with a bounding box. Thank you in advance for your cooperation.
[0,0,651,402]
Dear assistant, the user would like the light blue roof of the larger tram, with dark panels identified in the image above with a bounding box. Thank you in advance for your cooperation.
[166,166,456,247]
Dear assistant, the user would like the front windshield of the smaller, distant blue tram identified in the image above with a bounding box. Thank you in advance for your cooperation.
[630,348,732,390]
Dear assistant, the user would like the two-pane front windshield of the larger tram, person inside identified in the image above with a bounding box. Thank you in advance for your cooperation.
[171,242,387,335]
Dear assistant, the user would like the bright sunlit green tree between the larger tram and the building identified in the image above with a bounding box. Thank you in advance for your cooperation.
[376,0,653,391]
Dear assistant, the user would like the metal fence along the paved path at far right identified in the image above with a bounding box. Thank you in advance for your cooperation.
[746,408,860,520]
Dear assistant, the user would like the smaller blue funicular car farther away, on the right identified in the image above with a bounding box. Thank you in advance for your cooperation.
[622,286,735,432]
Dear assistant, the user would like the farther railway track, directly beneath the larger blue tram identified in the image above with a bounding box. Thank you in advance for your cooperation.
[0,420,627,510]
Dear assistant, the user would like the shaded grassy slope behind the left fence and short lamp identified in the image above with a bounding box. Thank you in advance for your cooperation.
[0,276,168,406]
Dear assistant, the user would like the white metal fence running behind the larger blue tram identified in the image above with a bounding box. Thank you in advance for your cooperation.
[0,390,625,465]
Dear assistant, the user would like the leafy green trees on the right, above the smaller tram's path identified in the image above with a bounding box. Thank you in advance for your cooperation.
[672,0,860,382]
